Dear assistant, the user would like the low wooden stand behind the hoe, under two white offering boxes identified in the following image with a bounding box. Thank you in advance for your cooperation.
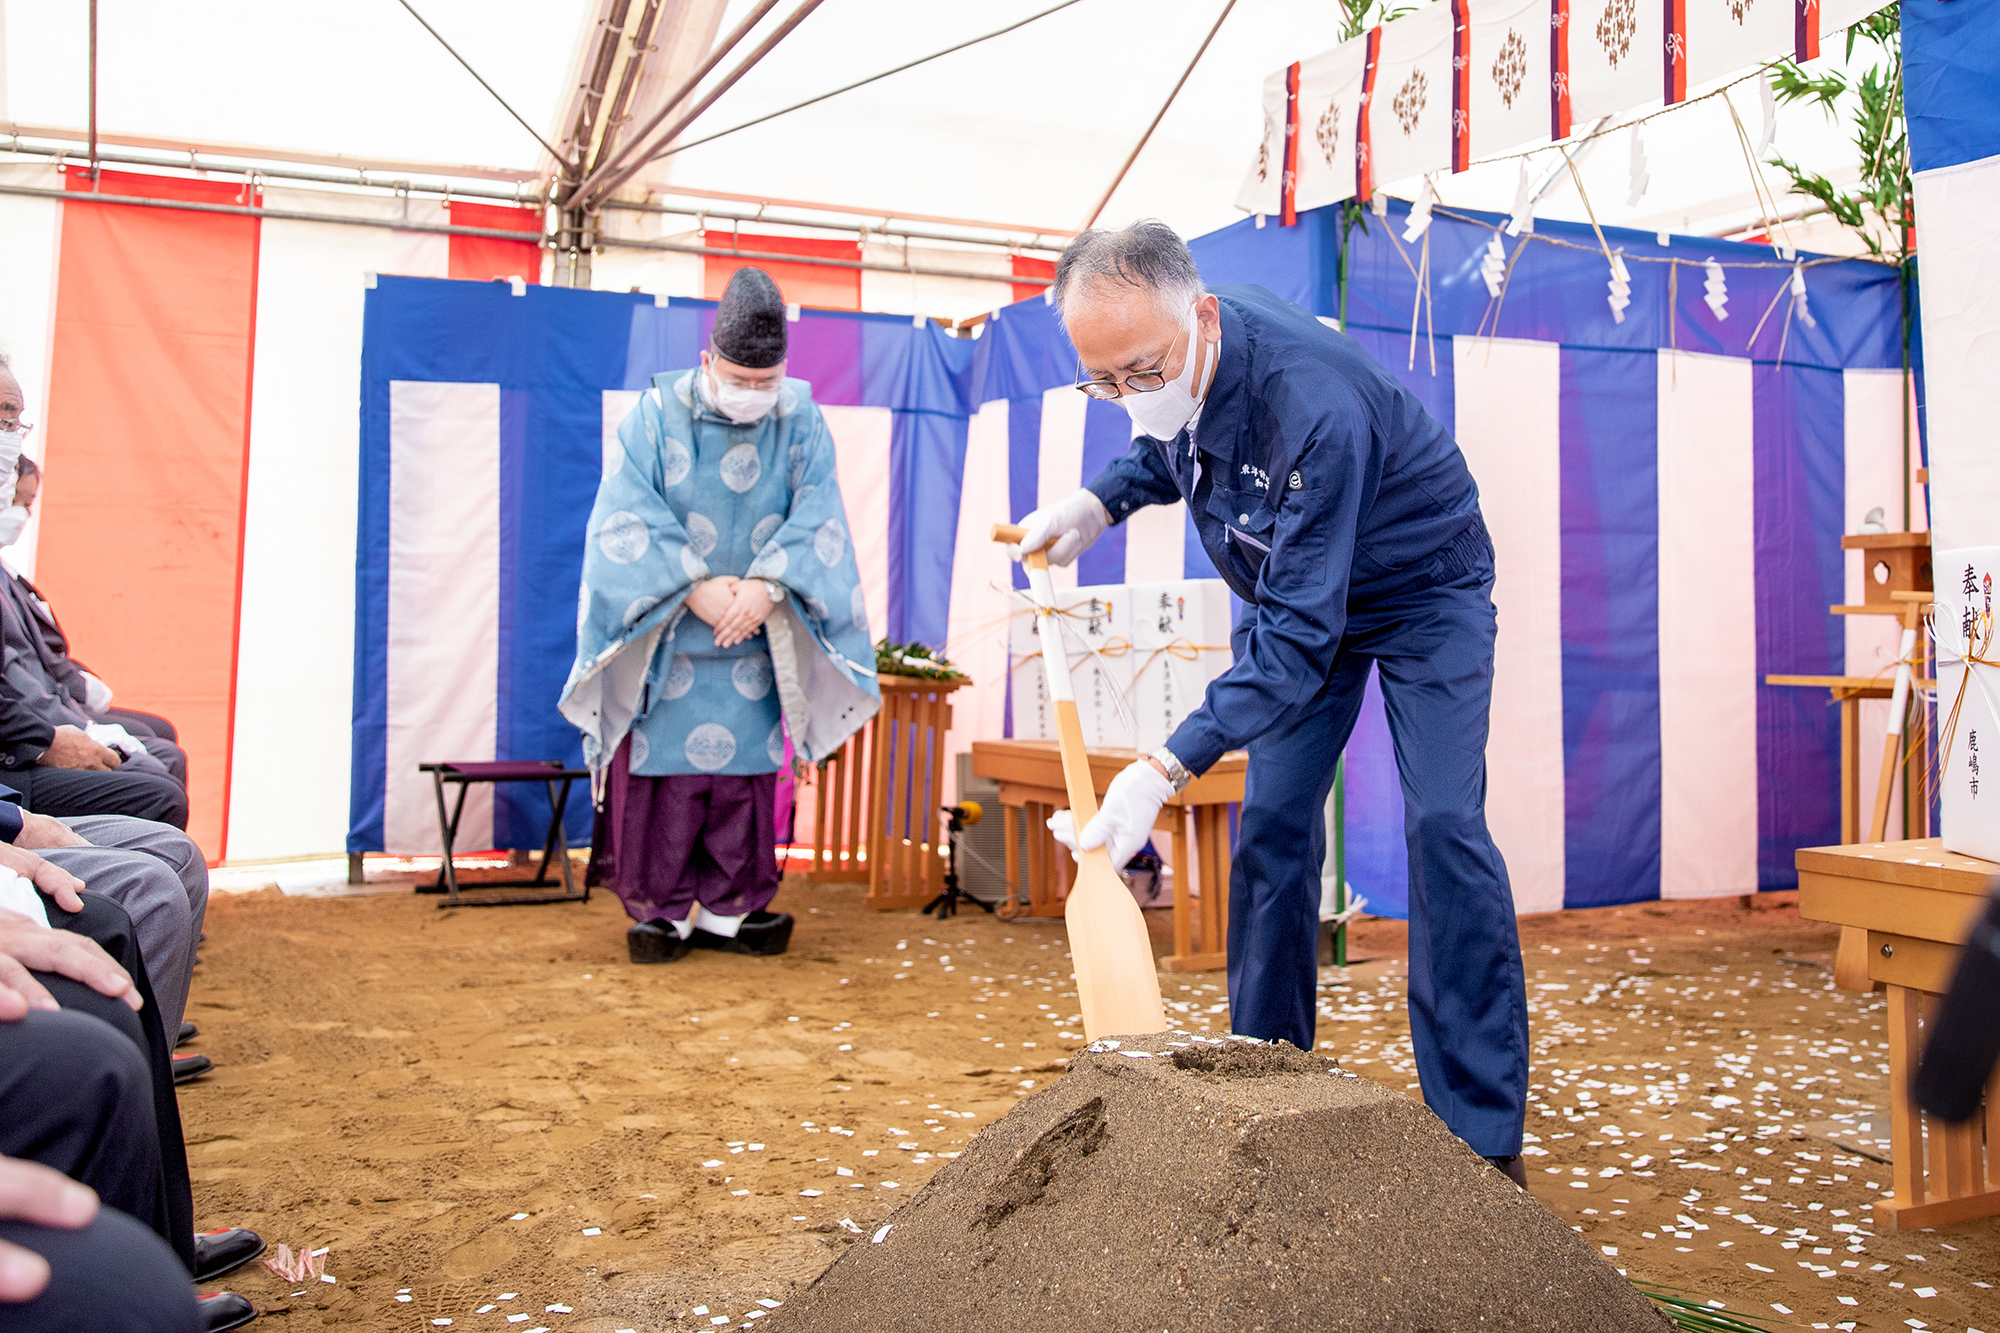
[972,741,1250,973]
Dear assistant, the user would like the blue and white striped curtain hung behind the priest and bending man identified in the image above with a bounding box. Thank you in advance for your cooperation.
[350,204,1924,913]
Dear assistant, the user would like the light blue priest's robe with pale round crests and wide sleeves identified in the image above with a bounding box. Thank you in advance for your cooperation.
[558,370,880,787]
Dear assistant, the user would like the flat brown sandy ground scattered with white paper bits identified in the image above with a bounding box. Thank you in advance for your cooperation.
[182,883,2000,1333]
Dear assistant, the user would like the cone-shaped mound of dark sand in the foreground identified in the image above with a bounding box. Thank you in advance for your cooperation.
[766,1035,1672,1333]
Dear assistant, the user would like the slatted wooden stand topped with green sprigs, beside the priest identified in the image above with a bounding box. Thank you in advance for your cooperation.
[866,675,972,911]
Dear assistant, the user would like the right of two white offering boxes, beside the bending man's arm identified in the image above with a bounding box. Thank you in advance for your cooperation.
[1126,578,1234,755]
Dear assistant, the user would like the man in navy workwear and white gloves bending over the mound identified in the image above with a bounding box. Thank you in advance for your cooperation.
[1022,222,1528,1183]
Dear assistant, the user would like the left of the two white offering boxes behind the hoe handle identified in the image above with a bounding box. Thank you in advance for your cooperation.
[1008,584,1132,749]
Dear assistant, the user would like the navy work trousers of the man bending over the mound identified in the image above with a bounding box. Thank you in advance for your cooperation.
[1230,560,1528,1157]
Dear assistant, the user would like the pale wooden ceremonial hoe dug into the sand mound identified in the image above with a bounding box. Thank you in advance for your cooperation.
[994,522,1166,1041]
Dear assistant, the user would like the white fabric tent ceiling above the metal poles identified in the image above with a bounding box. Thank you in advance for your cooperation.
[0,0,1880,256]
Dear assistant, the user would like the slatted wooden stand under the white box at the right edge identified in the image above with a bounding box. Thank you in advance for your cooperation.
[1798,839,2000,1231]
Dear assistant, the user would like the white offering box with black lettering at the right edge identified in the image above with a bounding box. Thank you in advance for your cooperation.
[1932,546,2000,861]
